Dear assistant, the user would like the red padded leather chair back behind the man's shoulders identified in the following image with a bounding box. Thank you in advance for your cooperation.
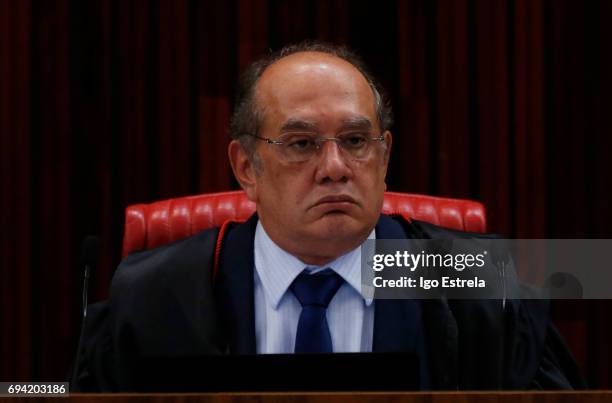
[123,191,486,257]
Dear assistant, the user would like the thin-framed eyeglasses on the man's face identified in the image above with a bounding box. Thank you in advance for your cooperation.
[248,132,385,162]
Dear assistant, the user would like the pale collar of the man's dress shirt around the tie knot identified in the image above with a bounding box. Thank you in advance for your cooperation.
[255,221,376,309]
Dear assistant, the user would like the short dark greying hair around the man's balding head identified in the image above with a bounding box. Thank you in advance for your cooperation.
[230,41,393,163]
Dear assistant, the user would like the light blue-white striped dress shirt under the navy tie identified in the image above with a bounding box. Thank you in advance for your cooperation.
[254,222,376,354]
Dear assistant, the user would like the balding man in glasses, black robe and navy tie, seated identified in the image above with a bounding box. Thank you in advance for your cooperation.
[77,44,581,390]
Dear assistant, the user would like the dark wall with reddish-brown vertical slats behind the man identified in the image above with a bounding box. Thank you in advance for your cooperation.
[0,0,612,388]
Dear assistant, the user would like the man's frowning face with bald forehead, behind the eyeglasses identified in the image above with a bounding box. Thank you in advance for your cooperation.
[230,52,391,264]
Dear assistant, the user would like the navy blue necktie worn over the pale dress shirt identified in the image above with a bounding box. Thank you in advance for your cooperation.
[291,269,344,353]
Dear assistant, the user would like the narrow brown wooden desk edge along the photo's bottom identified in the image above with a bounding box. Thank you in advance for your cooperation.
[0,390,612,403]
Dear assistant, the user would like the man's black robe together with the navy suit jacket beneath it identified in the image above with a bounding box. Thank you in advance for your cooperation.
[72,215,585,391]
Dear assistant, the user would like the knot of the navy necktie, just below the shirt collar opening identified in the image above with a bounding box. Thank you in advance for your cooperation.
[291,269,344,308]
